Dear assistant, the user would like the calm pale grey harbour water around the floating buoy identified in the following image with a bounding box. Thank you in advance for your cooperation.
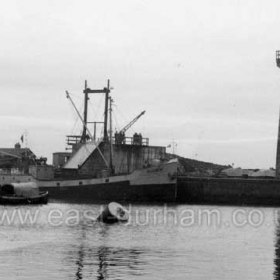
[0,203,280,280]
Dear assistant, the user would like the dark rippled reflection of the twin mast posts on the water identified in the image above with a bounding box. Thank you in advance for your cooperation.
[75,223,145,280]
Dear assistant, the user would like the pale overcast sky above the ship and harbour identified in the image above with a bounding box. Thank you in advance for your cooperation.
[0,0,280,168]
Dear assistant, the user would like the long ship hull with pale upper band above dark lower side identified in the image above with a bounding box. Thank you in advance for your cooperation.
[0,160,178,203]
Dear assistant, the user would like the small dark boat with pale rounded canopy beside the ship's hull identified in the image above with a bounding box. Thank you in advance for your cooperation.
[0,182,49,204]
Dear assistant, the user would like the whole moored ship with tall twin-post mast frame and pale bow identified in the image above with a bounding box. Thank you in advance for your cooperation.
[0,80,178,202]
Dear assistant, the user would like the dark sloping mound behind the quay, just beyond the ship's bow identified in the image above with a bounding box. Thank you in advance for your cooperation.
[167,154,231,176]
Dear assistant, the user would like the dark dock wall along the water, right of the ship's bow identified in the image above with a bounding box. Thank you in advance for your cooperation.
[177,177,280,206]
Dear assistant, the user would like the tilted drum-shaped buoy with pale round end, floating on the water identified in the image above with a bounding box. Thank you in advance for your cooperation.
[97,202,128,224]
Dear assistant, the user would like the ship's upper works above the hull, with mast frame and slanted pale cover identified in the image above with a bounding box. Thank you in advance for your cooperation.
[54,80,166,178]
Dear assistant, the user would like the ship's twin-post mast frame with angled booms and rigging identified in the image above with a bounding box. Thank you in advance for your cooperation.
[65,80,149,175]
